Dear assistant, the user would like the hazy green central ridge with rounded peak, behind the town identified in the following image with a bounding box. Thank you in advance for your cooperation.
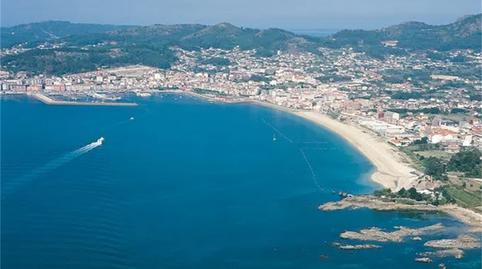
[65,23,318,55]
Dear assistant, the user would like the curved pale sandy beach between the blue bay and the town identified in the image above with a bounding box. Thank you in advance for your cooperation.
[294,111,417,190]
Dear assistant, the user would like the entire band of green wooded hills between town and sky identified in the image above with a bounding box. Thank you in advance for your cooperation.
[1,14,481,75]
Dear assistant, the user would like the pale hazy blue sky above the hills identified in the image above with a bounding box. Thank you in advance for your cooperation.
[0,0,481,30]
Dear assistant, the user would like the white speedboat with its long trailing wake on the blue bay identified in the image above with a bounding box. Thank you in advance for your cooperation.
[2,137,104,196]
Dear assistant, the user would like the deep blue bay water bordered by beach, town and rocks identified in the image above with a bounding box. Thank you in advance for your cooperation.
[1,95,481,269]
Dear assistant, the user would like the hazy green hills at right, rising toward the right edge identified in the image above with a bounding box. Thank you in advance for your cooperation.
[325,14,482,50]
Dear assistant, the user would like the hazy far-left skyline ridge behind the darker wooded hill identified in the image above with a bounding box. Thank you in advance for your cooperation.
[0,21,132,48]
